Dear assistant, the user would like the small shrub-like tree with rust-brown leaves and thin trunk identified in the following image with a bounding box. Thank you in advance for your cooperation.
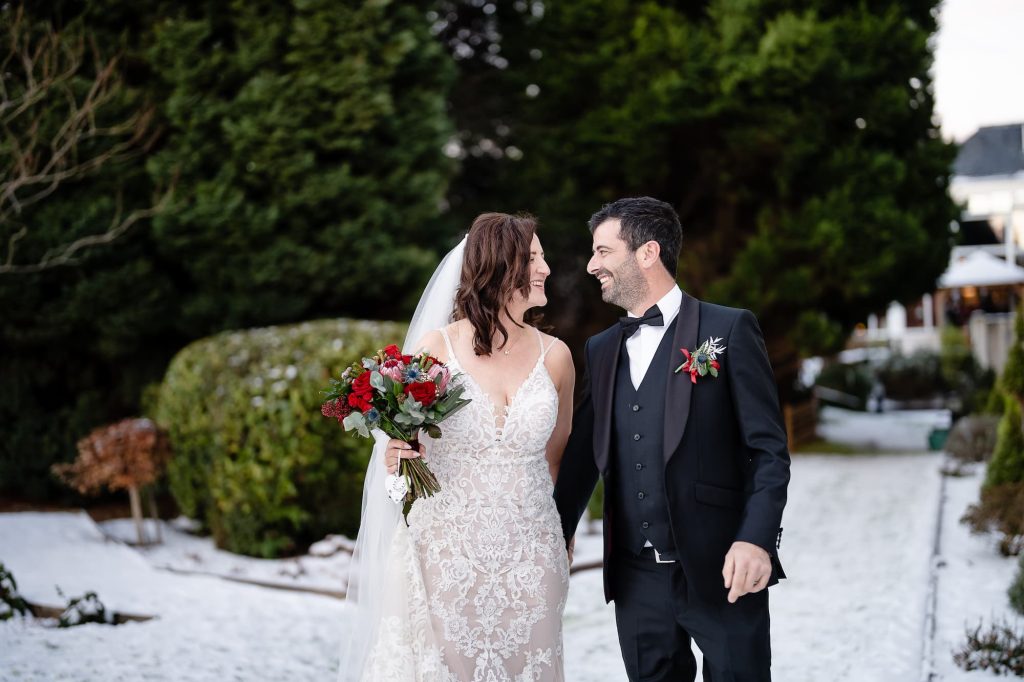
[53,419,171,545]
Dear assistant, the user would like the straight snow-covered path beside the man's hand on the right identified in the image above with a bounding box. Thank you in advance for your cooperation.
[771,454,941,682]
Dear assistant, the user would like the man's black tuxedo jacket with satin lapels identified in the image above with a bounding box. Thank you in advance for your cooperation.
[555,292,790,603]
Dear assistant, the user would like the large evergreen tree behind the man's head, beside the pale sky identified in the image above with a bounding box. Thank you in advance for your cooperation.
[440,0,956,392]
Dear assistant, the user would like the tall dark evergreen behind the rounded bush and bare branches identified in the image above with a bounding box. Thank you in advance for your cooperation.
[0,0,454,499]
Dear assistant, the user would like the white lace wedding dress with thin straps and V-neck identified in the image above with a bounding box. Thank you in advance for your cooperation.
[362,330,569,682]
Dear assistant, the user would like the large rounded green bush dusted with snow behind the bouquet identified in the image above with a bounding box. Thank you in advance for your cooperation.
[157,319,406,557]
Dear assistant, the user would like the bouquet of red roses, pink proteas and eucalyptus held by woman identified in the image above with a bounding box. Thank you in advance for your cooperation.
[321,344,470,503]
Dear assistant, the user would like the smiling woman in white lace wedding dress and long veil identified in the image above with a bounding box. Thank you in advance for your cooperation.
[339,213,574,682]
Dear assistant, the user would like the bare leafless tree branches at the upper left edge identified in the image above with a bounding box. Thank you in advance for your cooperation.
[0,4,173,274]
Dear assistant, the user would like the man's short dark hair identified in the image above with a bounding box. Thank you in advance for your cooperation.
[588,197,683,278]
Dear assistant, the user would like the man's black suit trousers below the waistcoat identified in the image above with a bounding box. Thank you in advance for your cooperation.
[612,548,771,682]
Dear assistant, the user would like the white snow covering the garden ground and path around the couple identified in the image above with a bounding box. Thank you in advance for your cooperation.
[0,405,1015,682]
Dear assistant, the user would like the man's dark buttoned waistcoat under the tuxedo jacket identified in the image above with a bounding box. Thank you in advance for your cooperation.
[611,315,679,558]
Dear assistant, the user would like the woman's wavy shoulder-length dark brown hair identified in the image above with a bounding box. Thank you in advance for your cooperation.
[453,213,537,355]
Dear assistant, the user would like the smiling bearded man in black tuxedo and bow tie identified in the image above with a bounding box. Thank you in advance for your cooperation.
[555,197,790,682]
